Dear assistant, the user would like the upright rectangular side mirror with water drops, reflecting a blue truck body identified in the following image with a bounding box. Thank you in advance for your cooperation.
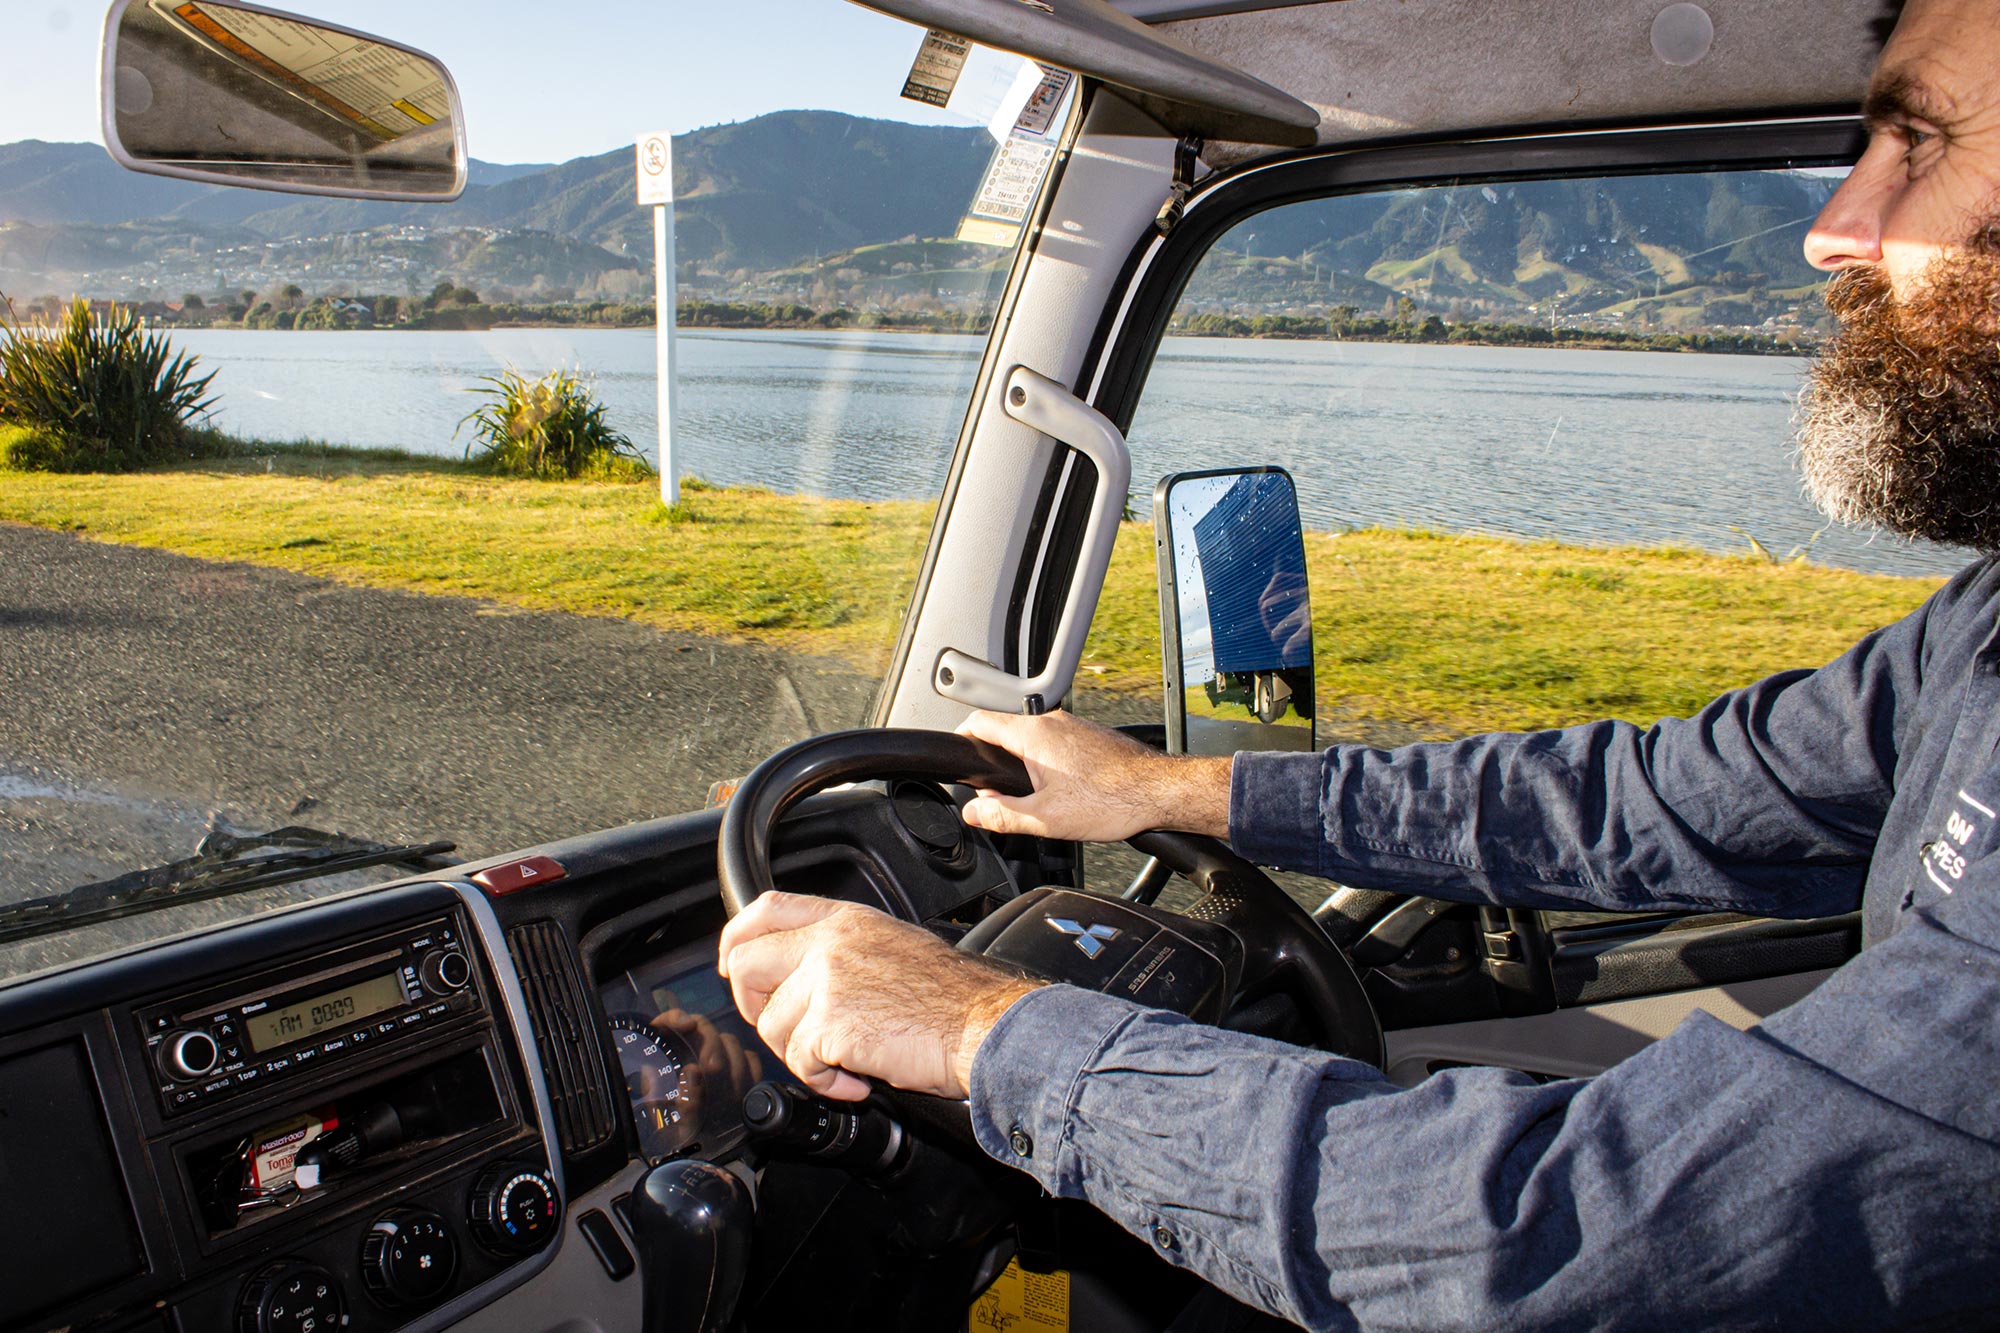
[1152,468,1318,755]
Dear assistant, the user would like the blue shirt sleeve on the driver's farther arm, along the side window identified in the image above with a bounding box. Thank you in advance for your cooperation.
[1230,576,1960,917]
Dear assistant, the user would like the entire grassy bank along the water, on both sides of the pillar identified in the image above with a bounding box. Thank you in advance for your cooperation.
[0,444,1936,737]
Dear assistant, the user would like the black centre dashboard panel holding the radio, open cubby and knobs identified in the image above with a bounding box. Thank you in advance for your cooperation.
[0,885,562,1333]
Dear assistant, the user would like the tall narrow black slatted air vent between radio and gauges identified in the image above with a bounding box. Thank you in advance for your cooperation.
[506,921,614,1157]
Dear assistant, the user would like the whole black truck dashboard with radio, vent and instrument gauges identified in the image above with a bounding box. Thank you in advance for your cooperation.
[0,789,1014,1333]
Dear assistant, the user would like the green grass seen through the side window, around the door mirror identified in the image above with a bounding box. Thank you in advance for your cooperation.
[1082,528,1940,737]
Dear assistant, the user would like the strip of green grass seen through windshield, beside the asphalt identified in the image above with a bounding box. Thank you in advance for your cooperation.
[0,442,932,669]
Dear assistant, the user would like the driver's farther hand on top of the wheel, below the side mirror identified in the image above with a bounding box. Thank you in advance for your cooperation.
[958,709,1232,843]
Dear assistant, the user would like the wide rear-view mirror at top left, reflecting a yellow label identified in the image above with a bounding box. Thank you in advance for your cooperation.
[100,0,466,202]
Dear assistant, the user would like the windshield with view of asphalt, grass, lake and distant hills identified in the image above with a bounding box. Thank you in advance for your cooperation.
[0,4,1062,960]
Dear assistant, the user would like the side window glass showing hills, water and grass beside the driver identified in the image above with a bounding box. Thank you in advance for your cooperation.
[1078,170,1966,892]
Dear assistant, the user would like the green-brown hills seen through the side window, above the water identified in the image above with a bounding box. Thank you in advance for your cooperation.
[1182,172,1834,332]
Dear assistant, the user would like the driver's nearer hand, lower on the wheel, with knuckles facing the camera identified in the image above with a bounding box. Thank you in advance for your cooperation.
[718,893,1038,1101]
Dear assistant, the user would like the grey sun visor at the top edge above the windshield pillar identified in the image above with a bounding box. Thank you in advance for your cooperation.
[856,0,1320,146]
